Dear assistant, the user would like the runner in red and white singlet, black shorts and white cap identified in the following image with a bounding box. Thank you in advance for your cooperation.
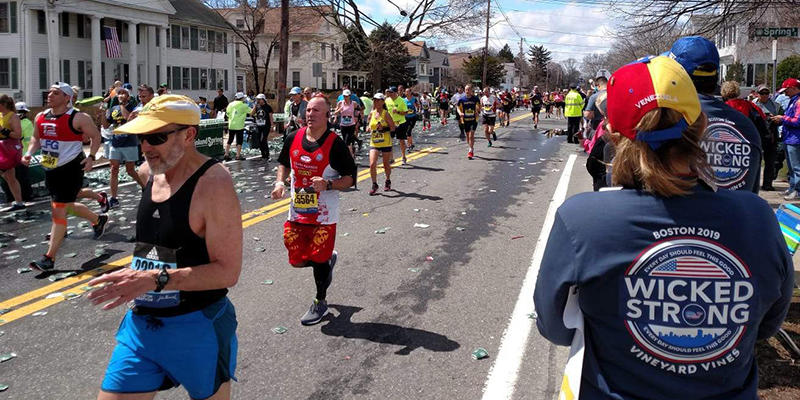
[22,82,108,271]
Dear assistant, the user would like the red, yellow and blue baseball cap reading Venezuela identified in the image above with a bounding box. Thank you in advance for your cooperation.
[606,56,701,150]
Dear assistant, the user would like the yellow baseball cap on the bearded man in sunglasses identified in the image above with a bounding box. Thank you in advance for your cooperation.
[114,94,200,135]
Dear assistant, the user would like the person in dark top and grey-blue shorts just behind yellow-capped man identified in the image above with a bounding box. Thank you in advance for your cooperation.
[102,87,145,208]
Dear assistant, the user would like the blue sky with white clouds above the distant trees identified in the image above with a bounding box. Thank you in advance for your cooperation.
[358,0,616,62]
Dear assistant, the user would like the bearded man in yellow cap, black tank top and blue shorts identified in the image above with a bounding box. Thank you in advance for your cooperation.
[89,94,242,400]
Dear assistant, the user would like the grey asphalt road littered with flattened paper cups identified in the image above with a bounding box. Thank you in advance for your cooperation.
[0,112,591,399]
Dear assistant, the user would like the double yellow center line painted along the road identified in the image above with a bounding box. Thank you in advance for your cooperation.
[0,147,443,326]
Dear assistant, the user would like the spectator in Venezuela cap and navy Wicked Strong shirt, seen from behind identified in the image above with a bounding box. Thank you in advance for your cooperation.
[534,56,793,400]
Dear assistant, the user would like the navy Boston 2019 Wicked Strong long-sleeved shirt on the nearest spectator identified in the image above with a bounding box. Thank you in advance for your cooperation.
[534,186,794,400]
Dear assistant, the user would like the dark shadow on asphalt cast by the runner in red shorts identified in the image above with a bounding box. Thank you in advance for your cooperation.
[321,304,461,356]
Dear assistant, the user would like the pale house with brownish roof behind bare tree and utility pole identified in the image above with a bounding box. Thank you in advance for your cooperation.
[217,7,346,91]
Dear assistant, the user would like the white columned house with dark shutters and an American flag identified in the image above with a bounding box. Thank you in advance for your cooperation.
[0,0,235,106]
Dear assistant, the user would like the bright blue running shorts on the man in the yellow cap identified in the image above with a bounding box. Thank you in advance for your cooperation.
[101,297,237,399]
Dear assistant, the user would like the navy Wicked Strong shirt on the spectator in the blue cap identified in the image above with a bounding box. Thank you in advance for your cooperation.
[700,94,761,193]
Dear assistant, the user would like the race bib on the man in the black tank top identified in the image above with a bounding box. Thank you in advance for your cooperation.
[131,242,181,308]
